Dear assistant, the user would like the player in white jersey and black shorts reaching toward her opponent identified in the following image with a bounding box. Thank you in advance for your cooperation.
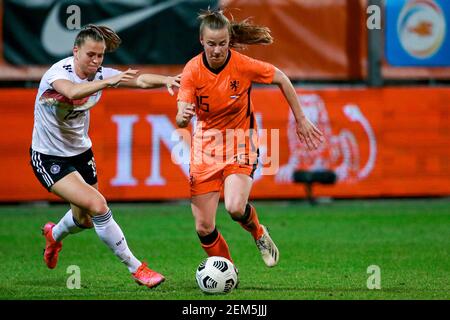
[30,25,180,288]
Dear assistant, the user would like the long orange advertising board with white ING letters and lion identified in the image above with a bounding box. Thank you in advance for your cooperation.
[0,87,450,202]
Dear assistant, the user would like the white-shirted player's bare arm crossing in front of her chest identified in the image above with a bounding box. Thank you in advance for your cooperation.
[52,69,138,100]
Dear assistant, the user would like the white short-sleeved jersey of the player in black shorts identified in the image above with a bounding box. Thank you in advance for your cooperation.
[31,57,120,157]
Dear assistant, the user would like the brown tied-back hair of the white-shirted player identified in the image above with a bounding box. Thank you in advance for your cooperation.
[74,24,122,52]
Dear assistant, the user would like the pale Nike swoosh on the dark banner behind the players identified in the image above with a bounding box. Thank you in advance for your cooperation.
[41,0,186,56]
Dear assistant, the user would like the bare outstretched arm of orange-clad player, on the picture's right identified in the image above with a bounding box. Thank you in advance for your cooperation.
[272,68,323,150]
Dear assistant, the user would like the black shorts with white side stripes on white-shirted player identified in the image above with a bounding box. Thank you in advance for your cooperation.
[30,148,97,191]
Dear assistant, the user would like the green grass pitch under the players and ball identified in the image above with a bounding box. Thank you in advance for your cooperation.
[0,199,450,300]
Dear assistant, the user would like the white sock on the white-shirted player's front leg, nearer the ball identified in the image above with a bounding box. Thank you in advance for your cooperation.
[92,210,141,273]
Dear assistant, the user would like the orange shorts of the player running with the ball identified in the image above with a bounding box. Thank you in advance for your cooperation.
[189,163,257,196]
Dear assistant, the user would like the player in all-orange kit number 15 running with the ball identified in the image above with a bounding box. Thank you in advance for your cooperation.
[176,10,323,267]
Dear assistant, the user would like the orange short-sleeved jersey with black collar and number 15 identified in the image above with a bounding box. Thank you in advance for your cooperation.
[178,50,275,168]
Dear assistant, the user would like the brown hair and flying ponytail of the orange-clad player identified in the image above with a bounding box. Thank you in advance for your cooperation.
[198,8,273,47]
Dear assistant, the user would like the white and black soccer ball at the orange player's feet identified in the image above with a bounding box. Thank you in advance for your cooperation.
[195,257,238,293]
